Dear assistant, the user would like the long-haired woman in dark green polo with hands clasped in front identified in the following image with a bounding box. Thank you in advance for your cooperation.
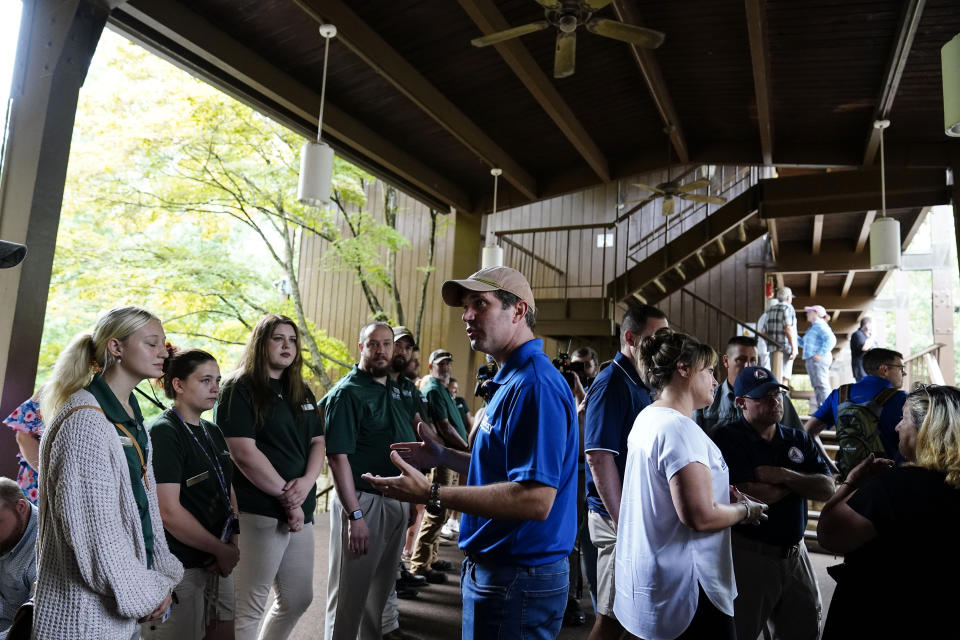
[214,314,324,640]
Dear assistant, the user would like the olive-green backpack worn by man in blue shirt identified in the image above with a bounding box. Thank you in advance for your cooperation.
[836,384,899,478]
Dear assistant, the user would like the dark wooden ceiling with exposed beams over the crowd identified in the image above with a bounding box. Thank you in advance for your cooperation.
[111,0,960,216]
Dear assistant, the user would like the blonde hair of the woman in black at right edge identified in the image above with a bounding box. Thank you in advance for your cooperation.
[907,385,960,489]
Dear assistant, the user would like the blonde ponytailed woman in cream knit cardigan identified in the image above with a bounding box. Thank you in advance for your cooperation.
[34,307,183,640]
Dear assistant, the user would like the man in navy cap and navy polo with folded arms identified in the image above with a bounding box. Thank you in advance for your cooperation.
[713,367,834,640]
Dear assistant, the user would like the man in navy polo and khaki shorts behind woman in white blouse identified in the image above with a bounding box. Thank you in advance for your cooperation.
[583,304,667,640]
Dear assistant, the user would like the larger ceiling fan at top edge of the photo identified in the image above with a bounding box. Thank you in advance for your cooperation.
[470,0,664,78]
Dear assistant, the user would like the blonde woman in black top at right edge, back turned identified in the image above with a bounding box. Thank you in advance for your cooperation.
[817,385,960,639]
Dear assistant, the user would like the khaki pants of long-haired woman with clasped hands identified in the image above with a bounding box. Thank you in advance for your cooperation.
[233,513,313,640]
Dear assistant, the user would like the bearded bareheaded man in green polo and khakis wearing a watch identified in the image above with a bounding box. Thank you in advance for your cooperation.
[324,322,410,640]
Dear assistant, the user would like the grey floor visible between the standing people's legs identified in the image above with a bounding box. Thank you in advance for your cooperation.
[278,513,841,640]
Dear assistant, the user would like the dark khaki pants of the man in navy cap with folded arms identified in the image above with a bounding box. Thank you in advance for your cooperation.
[733,534,821,640]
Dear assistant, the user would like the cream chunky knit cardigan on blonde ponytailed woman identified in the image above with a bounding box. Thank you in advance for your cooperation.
[33,390,183,640]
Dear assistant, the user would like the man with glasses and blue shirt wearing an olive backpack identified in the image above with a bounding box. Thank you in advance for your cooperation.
[803,349,907,477]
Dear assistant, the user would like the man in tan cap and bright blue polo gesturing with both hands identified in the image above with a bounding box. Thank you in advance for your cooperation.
[364,267,579,640]
